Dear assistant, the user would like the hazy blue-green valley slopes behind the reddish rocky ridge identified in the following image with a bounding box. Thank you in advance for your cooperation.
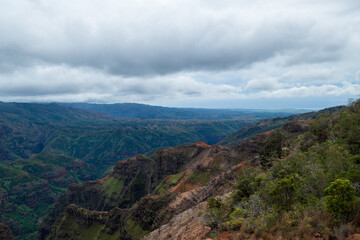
[0,103,262,239]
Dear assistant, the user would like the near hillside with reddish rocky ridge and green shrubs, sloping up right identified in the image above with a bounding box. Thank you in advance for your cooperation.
[44,100,360,240]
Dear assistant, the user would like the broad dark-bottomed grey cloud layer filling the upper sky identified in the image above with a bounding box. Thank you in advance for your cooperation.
[0,0,358,75]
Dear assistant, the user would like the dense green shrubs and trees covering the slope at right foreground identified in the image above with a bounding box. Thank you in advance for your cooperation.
[206,100,360,239]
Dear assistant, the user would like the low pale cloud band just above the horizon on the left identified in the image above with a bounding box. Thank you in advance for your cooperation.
[0,65,238,102]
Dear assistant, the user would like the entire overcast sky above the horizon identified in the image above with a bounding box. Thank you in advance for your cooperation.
[0,0,360,108]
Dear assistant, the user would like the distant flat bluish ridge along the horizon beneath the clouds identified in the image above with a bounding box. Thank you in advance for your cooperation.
[59,103,306,120]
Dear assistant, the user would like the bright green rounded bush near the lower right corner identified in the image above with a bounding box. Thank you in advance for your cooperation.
[324,179,355,220]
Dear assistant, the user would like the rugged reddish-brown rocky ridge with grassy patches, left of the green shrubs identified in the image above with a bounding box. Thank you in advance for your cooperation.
[40,120,308,240]
